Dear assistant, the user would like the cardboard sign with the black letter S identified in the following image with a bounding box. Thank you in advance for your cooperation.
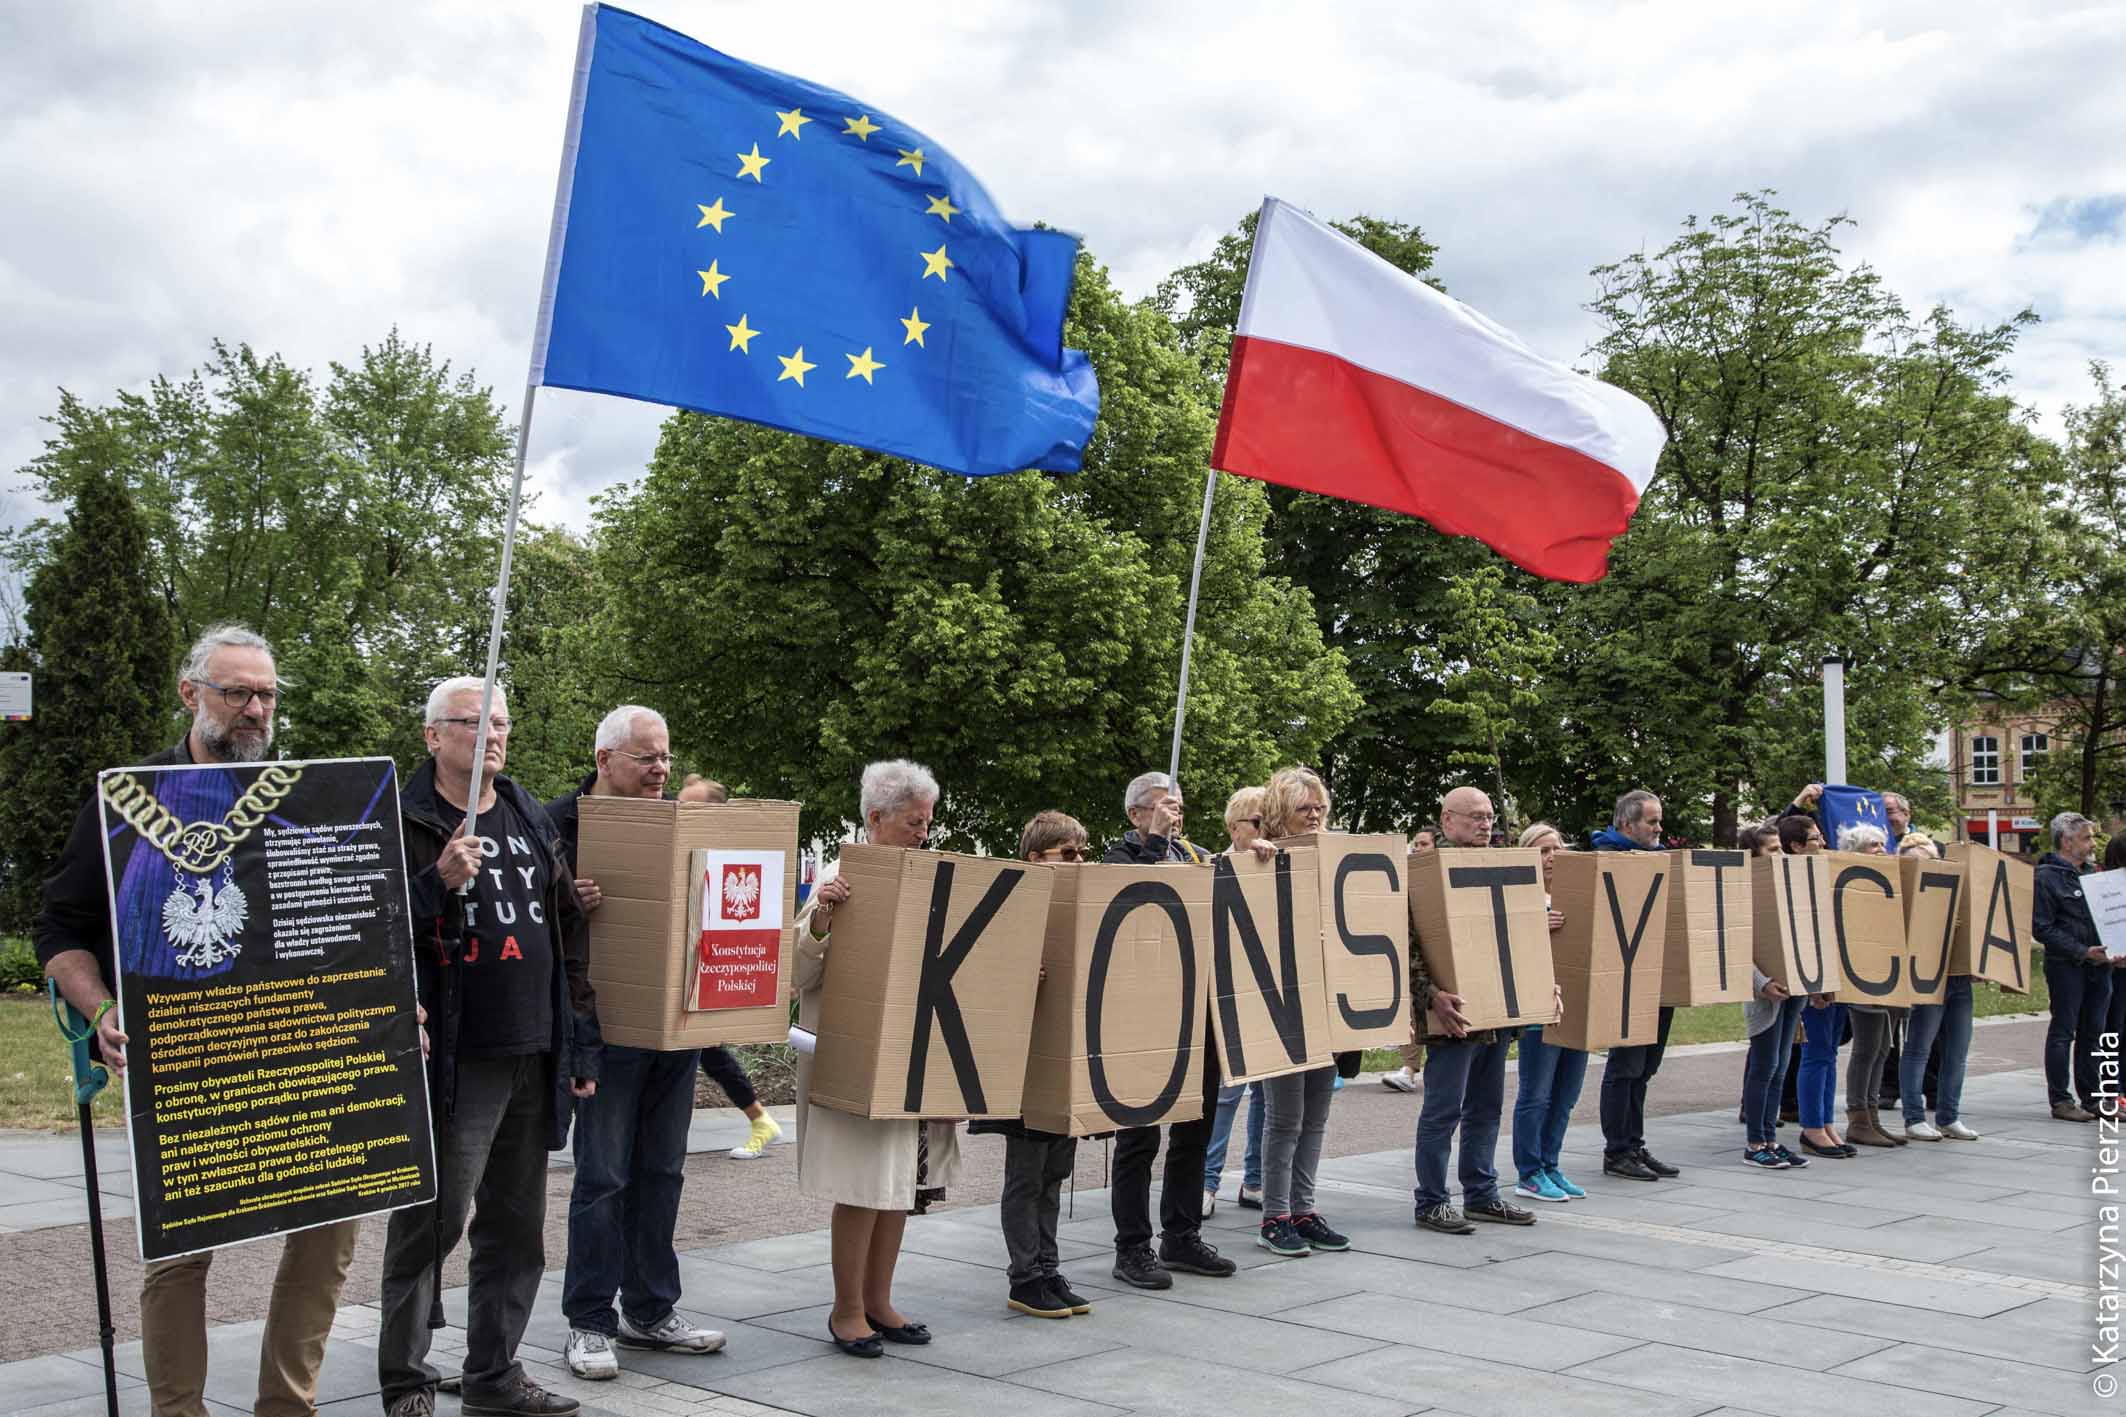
[1280,831,1410,1054]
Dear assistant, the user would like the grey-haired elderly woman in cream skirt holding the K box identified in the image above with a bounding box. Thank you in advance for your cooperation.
[795,761,959,1358]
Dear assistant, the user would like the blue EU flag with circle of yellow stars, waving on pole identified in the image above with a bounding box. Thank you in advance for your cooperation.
[532,4,1099,474]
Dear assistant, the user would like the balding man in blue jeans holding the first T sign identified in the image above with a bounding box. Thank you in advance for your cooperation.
[1410,788,1535,1234]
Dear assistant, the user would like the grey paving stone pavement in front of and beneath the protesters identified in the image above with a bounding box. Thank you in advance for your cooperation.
[0,1071,2126,1417]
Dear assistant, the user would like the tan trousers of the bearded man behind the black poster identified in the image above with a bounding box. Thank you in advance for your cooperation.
[140,1219,361,1417]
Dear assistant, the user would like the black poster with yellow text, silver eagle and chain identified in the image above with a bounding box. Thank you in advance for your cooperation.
[98,758,436,1260]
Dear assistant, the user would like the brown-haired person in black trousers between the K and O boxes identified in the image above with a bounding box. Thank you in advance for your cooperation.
[967,812,1093,1319]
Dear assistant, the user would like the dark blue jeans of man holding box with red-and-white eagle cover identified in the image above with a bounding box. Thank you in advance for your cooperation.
[561,1043,699,1338]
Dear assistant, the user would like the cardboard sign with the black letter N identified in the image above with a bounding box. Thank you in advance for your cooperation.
[1210,848,1335,1083]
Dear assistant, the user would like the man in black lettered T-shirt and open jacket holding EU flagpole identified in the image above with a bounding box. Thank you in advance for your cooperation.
[376,678,604,1417]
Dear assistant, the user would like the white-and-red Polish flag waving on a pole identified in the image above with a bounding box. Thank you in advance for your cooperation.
[1212,198,1667,580]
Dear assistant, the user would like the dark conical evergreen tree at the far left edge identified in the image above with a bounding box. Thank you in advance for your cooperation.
[0,472,176,931]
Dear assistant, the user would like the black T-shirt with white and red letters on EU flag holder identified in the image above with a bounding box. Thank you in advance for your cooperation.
[457,797,553,1058]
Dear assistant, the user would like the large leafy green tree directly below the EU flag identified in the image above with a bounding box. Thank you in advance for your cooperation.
[597,248,1354,850]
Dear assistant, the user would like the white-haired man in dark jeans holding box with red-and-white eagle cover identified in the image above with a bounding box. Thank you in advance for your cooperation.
[546,703,727,1381]
